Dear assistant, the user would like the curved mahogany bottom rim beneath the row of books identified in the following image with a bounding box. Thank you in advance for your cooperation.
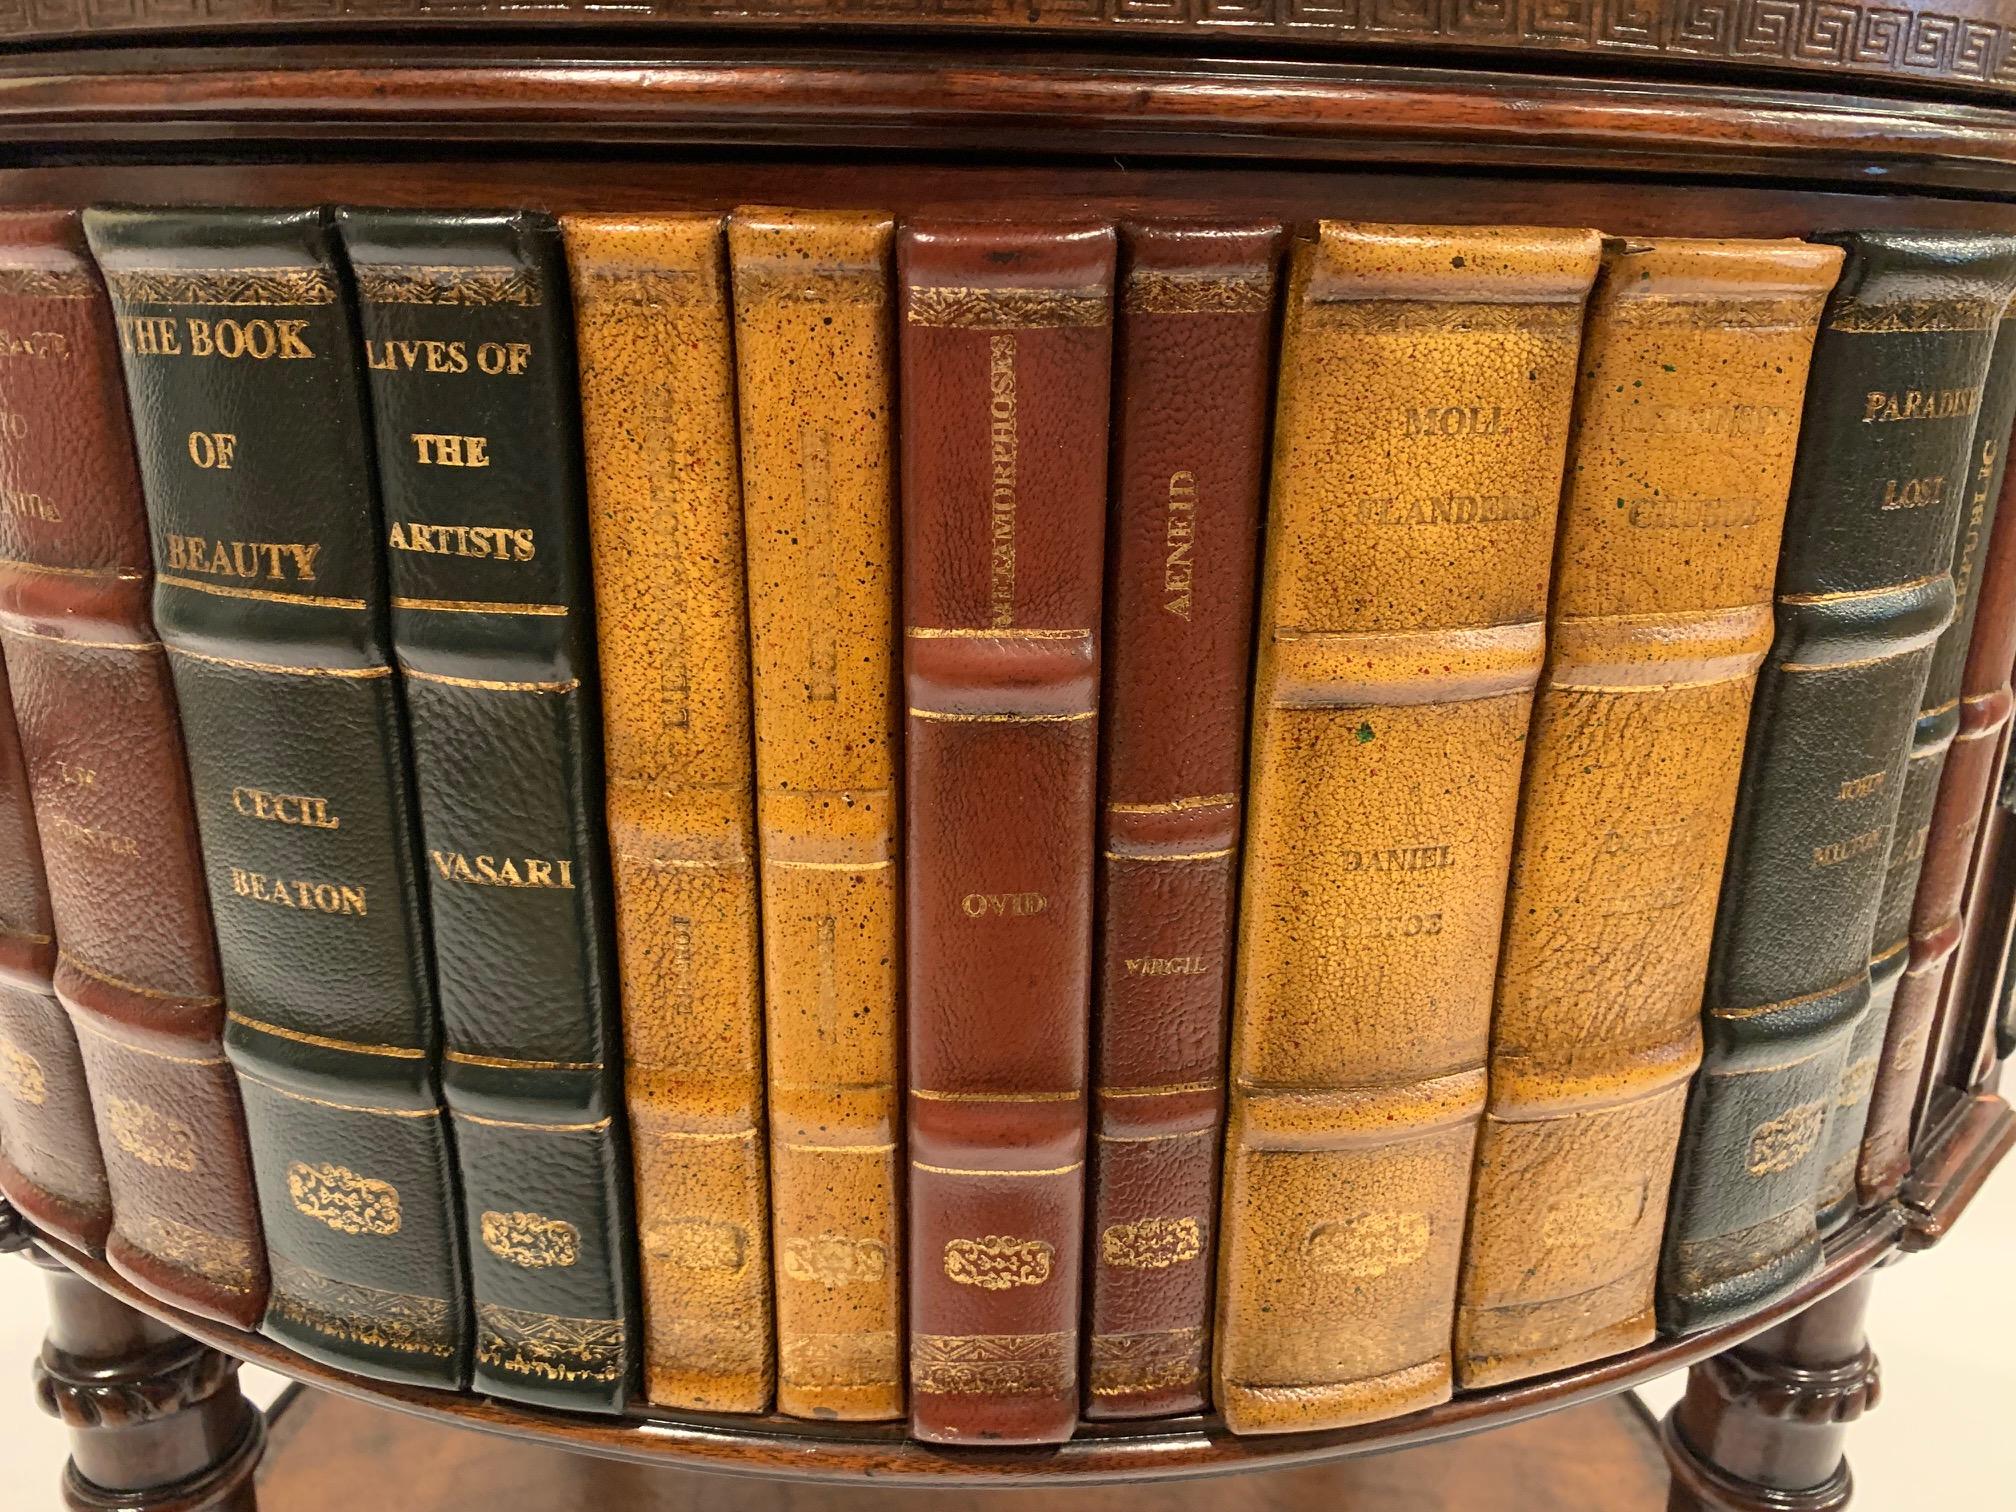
[15,1206,1903,1486]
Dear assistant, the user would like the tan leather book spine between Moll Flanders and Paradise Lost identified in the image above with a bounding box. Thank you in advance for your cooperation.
[1456,240,1841,1387]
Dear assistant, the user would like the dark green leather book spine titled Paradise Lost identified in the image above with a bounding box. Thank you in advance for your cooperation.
[1659,232,2016,1331]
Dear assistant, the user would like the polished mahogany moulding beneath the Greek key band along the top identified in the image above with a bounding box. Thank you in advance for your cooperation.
[0,42,2016,194]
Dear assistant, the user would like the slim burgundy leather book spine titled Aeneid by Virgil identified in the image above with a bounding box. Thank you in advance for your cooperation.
[1085,224,1280,1417]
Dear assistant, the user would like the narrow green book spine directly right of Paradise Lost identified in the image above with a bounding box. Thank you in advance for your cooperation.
[1818,319,2016,1234]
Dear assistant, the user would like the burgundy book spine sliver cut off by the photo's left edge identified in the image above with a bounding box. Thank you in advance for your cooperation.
[0,645,113,1250]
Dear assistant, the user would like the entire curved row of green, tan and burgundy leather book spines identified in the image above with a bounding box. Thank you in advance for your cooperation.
[0,208,2016,1443]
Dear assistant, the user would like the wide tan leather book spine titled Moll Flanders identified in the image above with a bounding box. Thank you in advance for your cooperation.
[1216,222,1601,1433]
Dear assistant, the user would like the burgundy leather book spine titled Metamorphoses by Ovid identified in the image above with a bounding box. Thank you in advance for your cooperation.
[897,224,1115,1443]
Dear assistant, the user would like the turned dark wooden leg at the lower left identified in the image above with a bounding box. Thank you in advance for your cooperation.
[0,1204,266,1512]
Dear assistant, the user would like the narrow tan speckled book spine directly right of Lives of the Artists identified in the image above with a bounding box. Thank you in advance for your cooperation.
[566,216,772,1411]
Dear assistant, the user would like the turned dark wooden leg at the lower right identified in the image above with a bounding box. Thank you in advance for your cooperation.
[1665,1276,1879,1512]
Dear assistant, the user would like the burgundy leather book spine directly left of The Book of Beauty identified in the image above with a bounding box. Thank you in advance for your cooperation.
[0,212,266,1329]
